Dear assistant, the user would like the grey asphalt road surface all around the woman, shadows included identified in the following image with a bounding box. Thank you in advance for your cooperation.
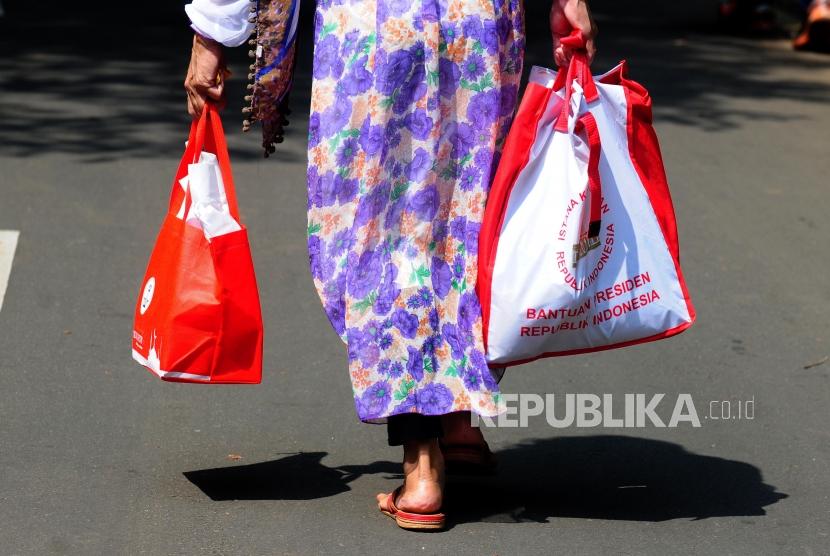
[0,1,830,555]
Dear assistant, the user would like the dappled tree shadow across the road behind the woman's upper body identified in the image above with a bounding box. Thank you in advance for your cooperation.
[0,0,830,162]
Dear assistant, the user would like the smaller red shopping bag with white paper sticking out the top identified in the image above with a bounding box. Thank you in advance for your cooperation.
[133,104,263,384]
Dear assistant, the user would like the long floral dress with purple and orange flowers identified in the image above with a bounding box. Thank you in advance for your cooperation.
[308,0,524,422]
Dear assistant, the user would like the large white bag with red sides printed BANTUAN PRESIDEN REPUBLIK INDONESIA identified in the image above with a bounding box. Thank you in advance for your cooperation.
[478,35,695,365]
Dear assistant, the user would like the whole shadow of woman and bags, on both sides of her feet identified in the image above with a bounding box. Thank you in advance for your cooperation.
[184,436,787,524]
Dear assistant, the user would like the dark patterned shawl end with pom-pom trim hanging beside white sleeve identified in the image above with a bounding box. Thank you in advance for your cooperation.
[242,0,300,158]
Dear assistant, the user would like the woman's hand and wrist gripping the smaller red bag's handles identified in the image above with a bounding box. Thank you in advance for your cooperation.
[184,34,230,118]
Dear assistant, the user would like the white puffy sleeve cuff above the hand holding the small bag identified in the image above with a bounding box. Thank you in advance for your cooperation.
[184,0,256,46]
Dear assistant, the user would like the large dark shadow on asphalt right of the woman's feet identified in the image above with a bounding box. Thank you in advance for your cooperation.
[447,436,787,523]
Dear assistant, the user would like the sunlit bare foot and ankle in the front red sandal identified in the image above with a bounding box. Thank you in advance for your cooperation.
[377,440,444,514]
